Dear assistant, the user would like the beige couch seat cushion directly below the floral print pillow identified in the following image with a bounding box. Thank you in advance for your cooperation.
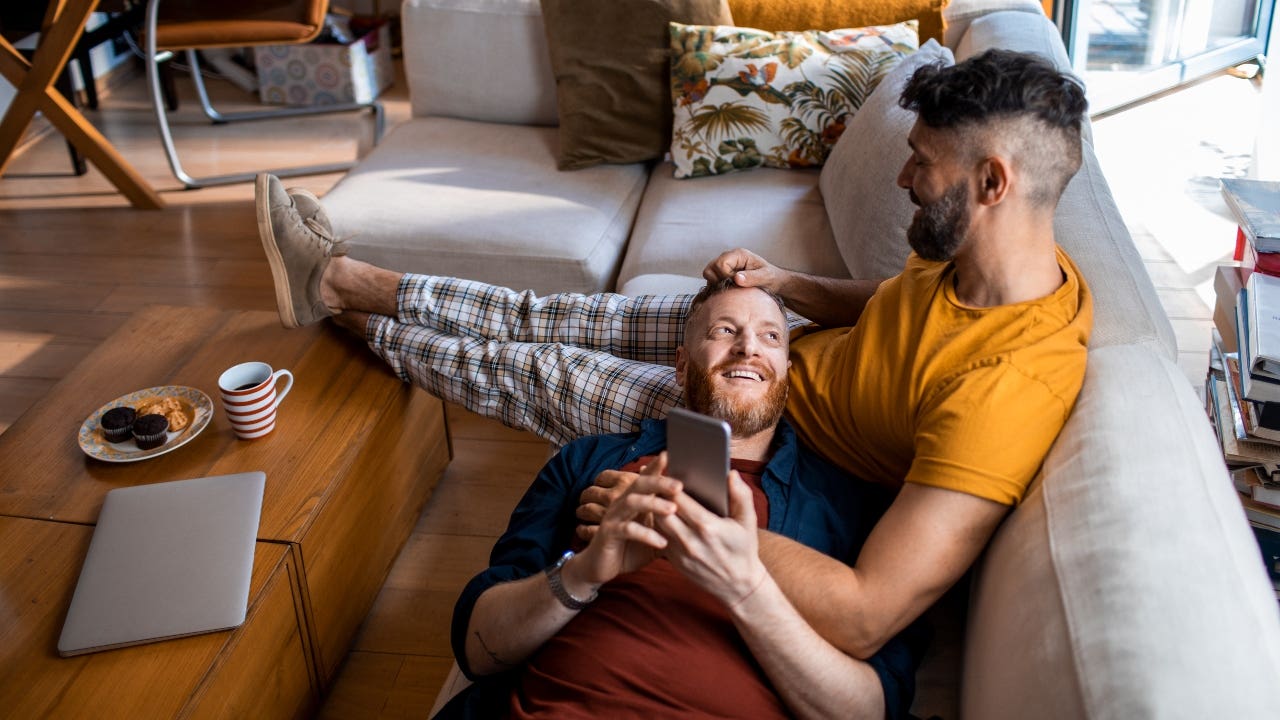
[618,163,847,295]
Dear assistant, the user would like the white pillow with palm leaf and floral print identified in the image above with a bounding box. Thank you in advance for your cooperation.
[671,20,920,178]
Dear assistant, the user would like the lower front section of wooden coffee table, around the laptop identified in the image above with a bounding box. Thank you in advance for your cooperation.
[0,516,309,719]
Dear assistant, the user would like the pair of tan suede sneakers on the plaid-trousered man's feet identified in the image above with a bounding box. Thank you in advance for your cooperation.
[255,173,347,328]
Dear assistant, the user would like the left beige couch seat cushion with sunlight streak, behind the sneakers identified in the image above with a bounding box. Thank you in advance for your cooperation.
[324,118,646,293]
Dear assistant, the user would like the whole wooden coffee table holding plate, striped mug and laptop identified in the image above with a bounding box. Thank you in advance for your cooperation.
[0,306,451,716]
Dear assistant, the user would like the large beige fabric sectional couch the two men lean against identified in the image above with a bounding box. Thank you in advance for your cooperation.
[324,0,1280,719]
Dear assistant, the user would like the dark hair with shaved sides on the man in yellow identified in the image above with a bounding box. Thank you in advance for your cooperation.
[899,49,1088,206]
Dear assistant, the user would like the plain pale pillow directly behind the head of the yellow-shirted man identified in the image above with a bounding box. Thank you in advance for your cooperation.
[818,40,951,279]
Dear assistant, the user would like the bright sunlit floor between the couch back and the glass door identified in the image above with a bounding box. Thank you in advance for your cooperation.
[1093,73,1265,393]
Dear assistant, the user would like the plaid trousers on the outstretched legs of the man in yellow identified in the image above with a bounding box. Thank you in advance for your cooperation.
[366,274,692,445]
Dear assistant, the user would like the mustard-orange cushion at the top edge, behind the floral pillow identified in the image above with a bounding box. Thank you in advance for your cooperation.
[728,0,947,41]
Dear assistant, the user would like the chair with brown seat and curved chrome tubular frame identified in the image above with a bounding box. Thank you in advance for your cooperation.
[143,0,383,188]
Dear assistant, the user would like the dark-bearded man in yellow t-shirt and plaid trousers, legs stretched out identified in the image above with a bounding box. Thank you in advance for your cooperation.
[257,50,1092,659]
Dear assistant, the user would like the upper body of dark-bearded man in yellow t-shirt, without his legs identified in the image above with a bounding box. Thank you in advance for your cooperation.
[705,50,1093,657]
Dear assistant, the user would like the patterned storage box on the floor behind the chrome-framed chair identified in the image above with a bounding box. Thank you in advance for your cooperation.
[253,23,393,105]
